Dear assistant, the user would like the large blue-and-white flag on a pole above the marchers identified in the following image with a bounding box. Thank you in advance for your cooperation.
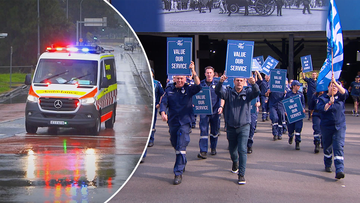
[316,0,344,92]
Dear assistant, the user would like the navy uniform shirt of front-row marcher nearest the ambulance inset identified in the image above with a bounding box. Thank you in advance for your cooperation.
[160,83,201,126]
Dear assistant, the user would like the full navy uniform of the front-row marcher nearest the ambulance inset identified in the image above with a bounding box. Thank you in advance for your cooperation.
[160,83,201,175]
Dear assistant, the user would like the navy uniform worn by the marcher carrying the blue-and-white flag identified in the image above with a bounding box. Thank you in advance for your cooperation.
[316,90,349,173]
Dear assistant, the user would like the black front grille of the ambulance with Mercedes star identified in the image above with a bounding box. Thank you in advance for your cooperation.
[40,97,79,111]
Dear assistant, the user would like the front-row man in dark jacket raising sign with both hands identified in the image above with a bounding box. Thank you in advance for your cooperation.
[215,74,260,185]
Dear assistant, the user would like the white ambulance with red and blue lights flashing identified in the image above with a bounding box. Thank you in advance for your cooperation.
[25,46,117,135]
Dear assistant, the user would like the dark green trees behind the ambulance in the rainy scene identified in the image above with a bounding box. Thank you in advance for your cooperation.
[0,0,124,70]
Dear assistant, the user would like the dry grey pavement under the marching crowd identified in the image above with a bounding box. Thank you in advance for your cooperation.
[109,104,360,203]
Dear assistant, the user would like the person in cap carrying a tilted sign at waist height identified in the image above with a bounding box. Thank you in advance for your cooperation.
[285,80,305,150]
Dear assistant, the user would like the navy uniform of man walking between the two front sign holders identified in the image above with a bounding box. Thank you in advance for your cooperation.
[199,79,220,152]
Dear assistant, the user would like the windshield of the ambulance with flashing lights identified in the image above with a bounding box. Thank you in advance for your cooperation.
[34,59,98,85]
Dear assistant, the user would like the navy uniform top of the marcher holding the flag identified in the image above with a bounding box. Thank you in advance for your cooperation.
[315,90,349,129]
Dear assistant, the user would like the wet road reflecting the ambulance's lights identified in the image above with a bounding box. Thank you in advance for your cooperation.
[0,47,152,202]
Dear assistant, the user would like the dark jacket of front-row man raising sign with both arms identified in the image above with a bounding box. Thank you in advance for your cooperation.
[215,82,260,128]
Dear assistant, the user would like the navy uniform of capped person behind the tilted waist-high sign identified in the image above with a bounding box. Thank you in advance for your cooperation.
[285,91,305,143]
